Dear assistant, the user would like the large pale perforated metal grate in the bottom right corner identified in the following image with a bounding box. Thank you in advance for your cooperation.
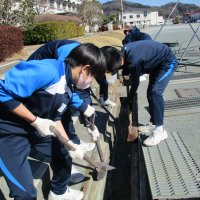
[142,132,200,199]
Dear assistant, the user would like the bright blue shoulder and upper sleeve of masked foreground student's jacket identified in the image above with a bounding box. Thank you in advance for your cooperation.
[0,61,59,110]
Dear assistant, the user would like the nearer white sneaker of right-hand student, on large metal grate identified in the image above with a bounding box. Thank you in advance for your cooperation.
[143,130,168,146]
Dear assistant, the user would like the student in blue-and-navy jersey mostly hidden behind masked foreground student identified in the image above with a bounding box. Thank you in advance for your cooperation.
[27,40,95,151]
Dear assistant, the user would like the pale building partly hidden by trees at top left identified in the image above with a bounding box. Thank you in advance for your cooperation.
[12,0,82,14]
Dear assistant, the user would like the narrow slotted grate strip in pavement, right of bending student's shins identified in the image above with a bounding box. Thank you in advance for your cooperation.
[165,97,200,111]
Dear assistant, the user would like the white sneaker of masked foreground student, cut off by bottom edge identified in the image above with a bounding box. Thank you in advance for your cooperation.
[48,187,83,200]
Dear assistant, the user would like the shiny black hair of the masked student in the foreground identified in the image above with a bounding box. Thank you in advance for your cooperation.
[66,43,106,77]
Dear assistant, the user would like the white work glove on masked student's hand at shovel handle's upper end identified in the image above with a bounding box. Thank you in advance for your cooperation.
[31,117,56,137]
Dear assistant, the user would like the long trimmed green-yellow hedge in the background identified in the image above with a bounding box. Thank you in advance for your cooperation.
[23,21,84,45]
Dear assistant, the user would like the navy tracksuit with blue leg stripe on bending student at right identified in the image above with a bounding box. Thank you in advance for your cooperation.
[122,40,177,126]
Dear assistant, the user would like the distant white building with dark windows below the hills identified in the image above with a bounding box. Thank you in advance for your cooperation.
[120,8,164,26]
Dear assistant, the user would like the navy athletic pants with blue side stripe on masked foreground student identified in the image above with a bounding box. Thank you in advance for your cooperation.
[0,134,72,200]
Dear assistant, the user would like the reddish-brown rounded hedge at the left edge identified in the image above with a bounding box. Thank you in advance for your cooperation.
[0,25,23,61]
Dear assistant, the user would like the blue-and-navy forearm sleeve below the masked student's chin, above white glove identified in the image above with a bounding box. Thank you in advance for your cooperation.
[70,92,88,113]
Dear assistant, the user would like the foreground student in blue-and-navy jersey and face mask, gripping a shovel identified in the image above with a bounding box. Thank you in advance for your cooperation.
[0,44,106,200]
